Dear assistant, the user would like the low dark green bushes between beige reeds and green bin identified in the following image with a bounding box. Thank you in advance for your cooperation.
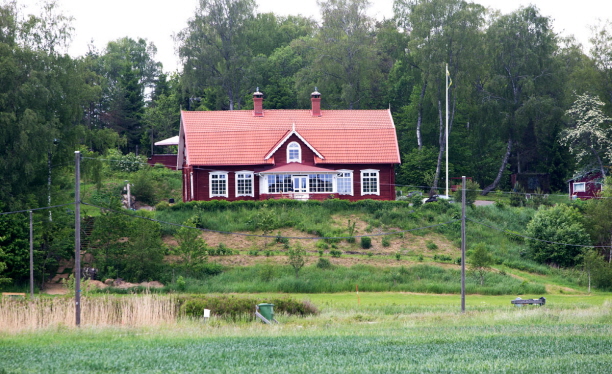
[179,296,318,320]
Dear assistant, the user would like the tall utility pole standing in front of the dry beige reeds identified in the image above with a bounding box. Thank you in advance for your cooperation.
[74,151,81,327]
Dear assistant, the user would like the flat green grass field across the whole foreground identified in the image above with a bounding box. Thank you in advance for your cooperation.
[0,293,612,373]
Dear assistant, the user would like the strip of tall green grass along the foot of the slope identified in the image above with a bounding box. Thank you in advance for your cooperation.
[164,264,546,295]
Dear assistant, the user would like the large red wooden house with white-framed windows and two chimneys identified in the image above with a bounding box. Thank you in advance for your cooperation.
[177,91,400,201]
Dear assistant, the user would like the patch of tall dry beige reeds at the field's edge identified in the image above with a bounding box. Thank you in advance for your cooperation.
[0,295,178,332]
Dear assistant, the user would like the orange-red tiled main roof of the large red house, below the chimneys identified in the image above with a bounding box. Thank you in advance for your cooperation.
[181,110,400,165]
